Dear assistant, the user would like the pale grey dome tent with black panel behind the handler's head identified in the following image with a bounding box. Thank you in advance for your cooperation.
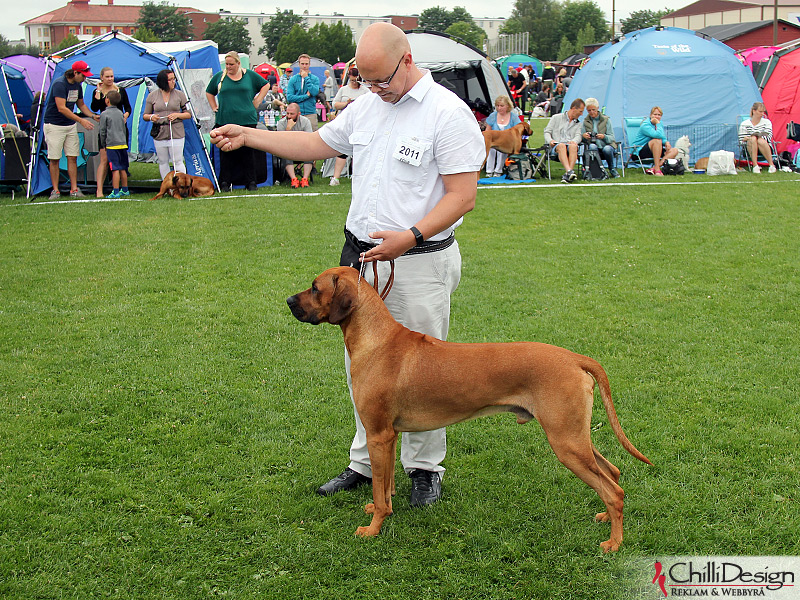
[406,29,511,115]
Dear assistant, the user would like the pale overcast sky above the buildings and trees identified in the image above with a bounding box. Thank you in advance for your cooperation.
[0,0,692,43]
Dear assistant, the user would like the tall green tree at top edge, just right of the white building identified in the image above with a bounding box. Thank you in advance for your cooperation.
[500,0,561,60]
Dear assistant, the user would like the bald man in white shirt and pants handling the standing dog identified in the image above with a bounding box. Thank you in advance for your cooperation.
[211,23,486,506]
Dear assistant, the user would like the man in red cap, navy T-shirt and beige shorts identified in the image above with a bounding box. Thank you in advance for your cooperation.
[44,60,100,200]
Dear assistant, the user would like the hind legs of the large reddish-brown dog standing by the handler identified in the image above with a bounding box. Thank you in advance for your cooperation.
[548,436,625,552]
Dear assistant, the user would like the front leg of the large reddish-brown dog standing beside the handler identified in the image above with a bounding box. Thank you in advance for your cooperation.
[356,429,397,537]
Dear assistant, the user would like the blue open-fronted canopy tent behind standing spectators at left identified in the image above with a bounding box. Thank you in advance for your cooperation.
[28,31,216,198]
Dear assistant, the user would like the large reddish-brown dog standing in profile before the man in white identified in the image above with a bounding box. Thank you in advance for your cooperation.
[287,267,652,552]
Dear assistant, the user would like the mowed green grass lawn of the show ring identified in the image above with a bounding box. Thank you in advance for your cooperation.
[0,173,800,600]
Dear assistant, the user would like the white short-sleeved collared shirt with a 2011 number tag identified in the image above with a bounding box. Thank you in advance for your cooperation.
[319,71,486,241]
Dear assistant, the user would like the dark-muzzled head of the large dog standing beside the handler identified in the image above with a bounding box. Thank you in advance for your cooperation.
[286,267,358,325]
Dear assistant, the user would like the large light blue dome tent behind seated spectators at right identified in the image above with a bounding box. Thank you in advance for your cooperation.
[564,27,761,163]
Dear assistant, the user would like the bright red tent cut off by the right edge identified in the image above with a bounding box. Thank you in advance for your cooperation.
[757,42,800,152]
